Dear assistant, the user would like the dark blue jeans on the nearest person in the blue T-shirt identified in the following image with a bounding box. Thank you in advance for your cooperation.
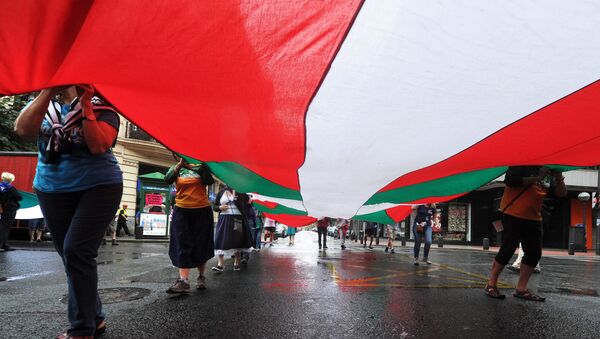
[36,184,123,336]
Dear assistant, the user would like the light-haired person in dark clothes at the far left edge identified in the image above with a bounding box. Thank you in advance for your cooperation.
[0,172,23,251]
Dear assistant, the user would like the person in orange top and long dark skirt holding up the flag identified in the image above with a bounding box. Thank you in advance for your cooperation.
[165,154,215,293]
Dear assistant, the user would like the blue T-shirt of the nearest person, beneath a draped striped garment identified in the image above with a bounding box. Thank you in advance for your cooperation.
[33,98,123,193]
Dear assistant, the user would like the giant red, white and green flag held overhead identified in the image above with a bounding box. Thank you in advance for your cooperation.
[0,0,600,224]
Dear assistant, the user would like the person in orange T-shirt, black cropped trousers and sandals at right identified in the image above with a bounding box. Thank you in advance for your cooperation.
[485,166,567,301]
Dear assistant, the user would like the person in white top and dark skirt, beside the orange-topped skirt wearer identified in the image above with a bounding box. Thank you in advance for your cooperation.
[212,187,252,272]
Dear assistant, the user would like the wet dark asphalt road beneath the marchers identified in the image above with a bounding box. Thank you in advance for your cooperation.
[0,232,600,338]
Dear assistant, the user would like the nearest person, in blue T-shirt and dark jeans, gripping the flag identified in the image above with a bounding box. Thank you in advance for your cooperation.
[15,85,123,338]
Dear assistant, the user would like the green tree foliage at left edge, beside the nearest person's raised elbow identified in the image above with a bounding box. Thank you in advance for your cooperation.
[0,94,37,152]
